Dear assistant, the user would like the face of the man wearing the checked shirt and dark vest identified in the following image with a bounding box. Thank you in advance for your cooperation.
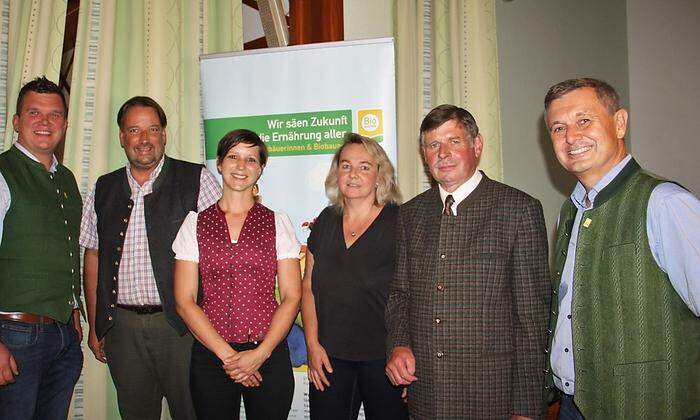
[119,106,167,173]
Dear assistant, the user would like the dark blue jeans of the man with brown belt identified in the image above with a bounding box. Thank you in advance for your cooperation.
[0,317,83,420]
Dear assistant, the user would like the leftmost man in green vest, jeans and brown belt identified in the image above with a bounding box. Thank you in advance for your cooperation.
[0,77,83,420]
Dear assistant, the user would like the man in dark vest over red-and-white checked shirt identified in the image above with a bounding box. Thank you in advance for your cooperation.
[80,96,221,420]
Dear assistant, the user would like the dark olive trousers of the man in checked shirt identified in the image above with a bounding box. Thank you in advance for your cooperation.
[104,308,195,420]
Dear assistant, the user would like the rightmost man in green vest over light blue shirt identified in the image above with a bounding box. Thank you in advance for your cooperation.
[545,78,700,420]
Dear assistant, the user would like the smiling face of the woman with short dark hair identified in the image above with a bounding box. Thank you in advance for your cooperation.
[216,143,263,193]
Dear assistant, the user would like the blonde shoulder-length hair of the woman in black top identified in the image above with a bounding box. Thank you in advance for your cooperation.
[326,133,401,211]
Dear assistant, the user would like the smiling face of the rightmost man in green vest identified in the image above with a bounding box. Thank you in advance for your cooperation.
[546,87,627,190]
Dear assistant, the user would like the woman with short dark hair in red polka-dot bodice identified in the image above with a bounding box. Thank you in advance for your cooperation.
[173,130,301,419]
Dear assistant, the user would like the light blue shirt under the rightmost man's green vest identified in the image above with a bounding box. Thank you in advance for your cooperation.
[550,155,700,395]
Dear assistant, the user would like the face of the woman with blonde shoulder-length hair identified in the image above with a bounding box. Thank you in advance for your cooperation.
[338,143,379,201]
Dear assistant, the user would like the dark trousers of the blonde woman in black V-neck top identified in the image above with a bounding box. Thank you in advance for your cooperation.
[309,358,408,420]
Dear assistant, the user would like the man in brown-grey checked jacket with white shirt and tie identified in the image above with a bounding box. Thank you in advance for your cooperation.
[386,105,550,419]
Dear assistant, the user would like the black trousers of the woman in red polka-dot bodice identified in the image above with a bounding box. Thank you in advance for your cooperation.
[190,341,294,420]
